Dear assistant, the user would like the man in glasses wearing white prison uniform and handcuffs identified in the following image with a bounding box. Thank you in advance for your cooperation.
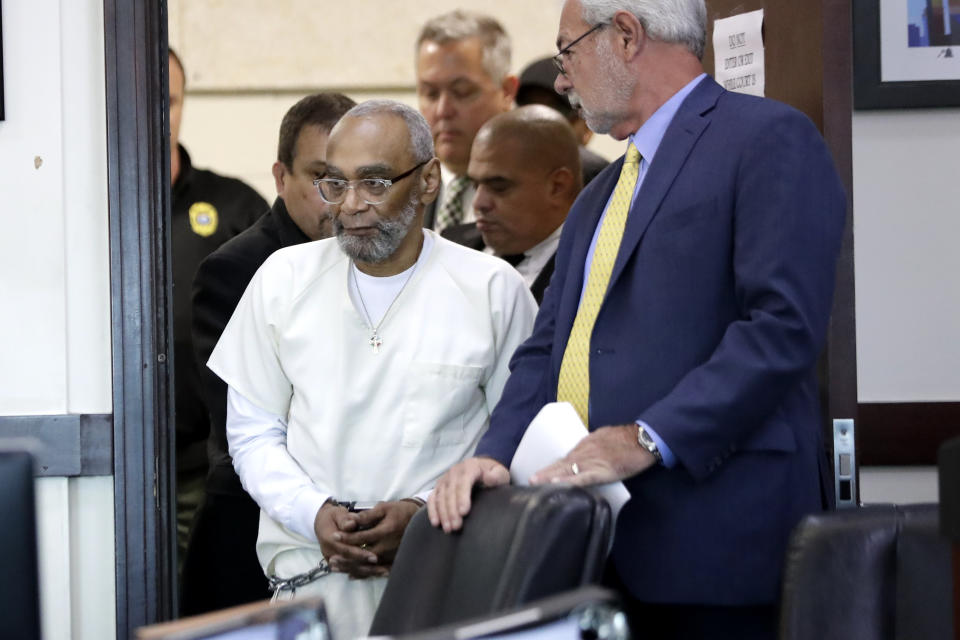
[208,101,536,638]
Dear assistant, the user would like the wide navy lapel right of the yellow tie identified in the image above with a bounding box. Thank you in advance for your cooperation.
[612,77,723,291]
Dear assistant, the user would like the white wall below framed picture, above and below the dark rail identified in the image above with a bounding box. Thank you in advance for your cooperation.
[853,109,960,503]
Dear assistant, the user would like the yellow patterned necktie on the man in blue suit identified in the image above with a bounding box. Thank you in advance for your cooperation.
[557,143,640,429]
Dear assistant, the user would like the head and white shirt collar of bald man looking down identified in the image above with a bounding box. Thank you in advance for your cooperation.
[467,105,580,304]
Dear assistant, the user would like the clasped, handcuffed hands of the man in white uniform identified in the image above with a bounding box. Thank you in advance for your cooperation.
[313,500,420,579]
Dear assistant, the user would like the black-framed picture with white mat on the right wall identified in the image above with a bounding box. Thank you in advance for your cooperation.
[853,0,960,109]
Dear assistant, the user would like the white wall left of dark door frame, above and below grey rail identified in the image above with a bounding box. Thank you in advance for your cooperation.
[0,0,115,640]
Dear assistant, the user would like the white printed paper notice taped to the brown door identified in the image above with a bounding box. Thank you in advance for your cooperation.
[713,9,766,96]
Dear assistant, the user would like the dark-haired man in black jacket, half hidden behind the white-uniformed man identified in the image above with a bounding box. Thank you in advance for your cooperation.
[181,93,355,615]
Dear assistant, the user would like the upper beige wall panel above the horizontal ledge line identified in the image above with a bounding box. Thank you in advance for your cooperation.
[170,0,560,90]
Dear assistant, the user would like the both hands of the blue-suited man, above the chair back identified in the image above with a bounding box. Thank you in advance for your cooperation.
[427,423,656,533]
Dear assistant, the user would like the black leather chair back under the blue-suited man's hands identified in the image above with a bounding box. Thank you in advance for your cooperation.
[370,486,612,635]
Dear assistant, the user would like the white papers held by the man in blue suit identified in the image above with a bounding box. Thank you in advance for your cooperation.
[510,402,630,523]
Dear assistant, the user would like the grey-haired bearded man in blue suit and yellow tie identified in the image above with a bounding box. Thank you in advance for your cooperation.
[429,0,846,639]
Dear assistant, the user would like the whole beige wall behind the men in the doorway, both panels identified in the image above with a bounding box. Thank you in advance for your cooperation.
[168,0,624,201]
